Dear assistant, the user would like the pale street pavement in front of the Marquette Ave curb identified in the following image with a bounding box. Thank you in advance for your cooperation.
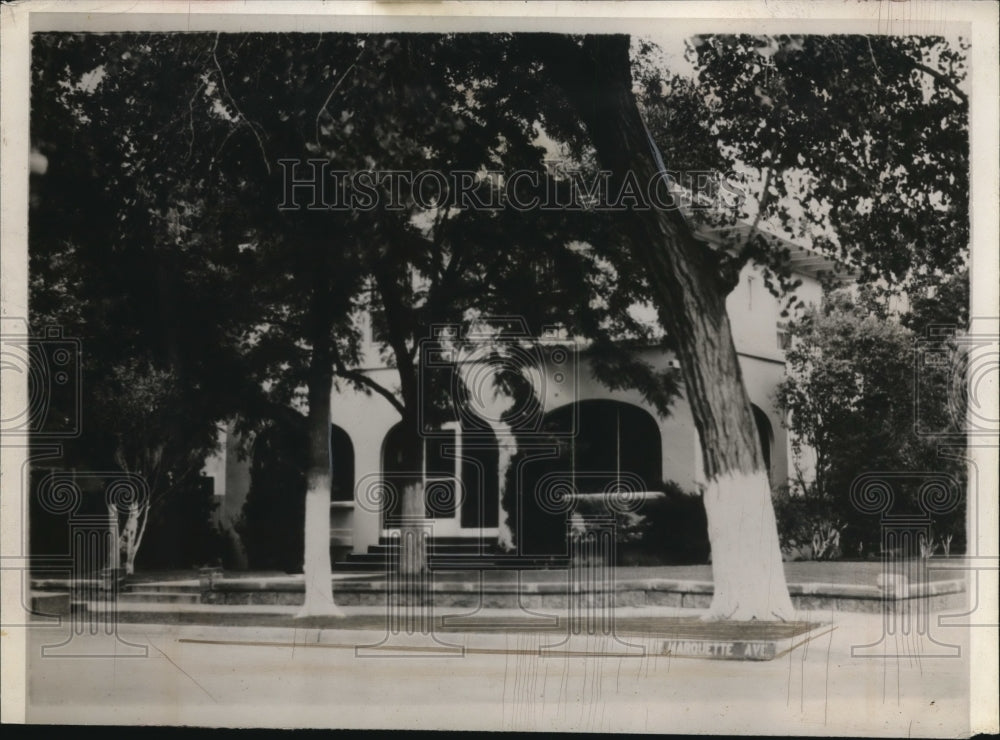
[21,607,969,736]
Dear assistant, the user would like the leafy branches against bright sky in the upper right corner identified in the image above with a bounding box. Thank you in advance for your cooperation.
[688,35,969,290]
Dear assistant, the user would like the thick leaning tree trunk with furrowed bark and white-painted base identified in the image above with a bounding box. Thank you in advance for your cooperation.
[542,36,794,620]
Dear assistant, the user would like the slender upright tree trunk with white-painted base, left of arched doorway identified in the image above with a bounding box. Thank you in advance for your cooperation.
[296,350,343,617]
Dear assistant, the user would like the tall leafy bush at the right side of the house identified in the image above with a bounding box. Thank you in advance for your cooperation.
[778,291,964,556]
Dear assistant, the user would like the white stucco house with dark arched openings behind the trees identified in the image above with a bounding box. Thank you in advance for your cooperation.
[206,228,834,560]
